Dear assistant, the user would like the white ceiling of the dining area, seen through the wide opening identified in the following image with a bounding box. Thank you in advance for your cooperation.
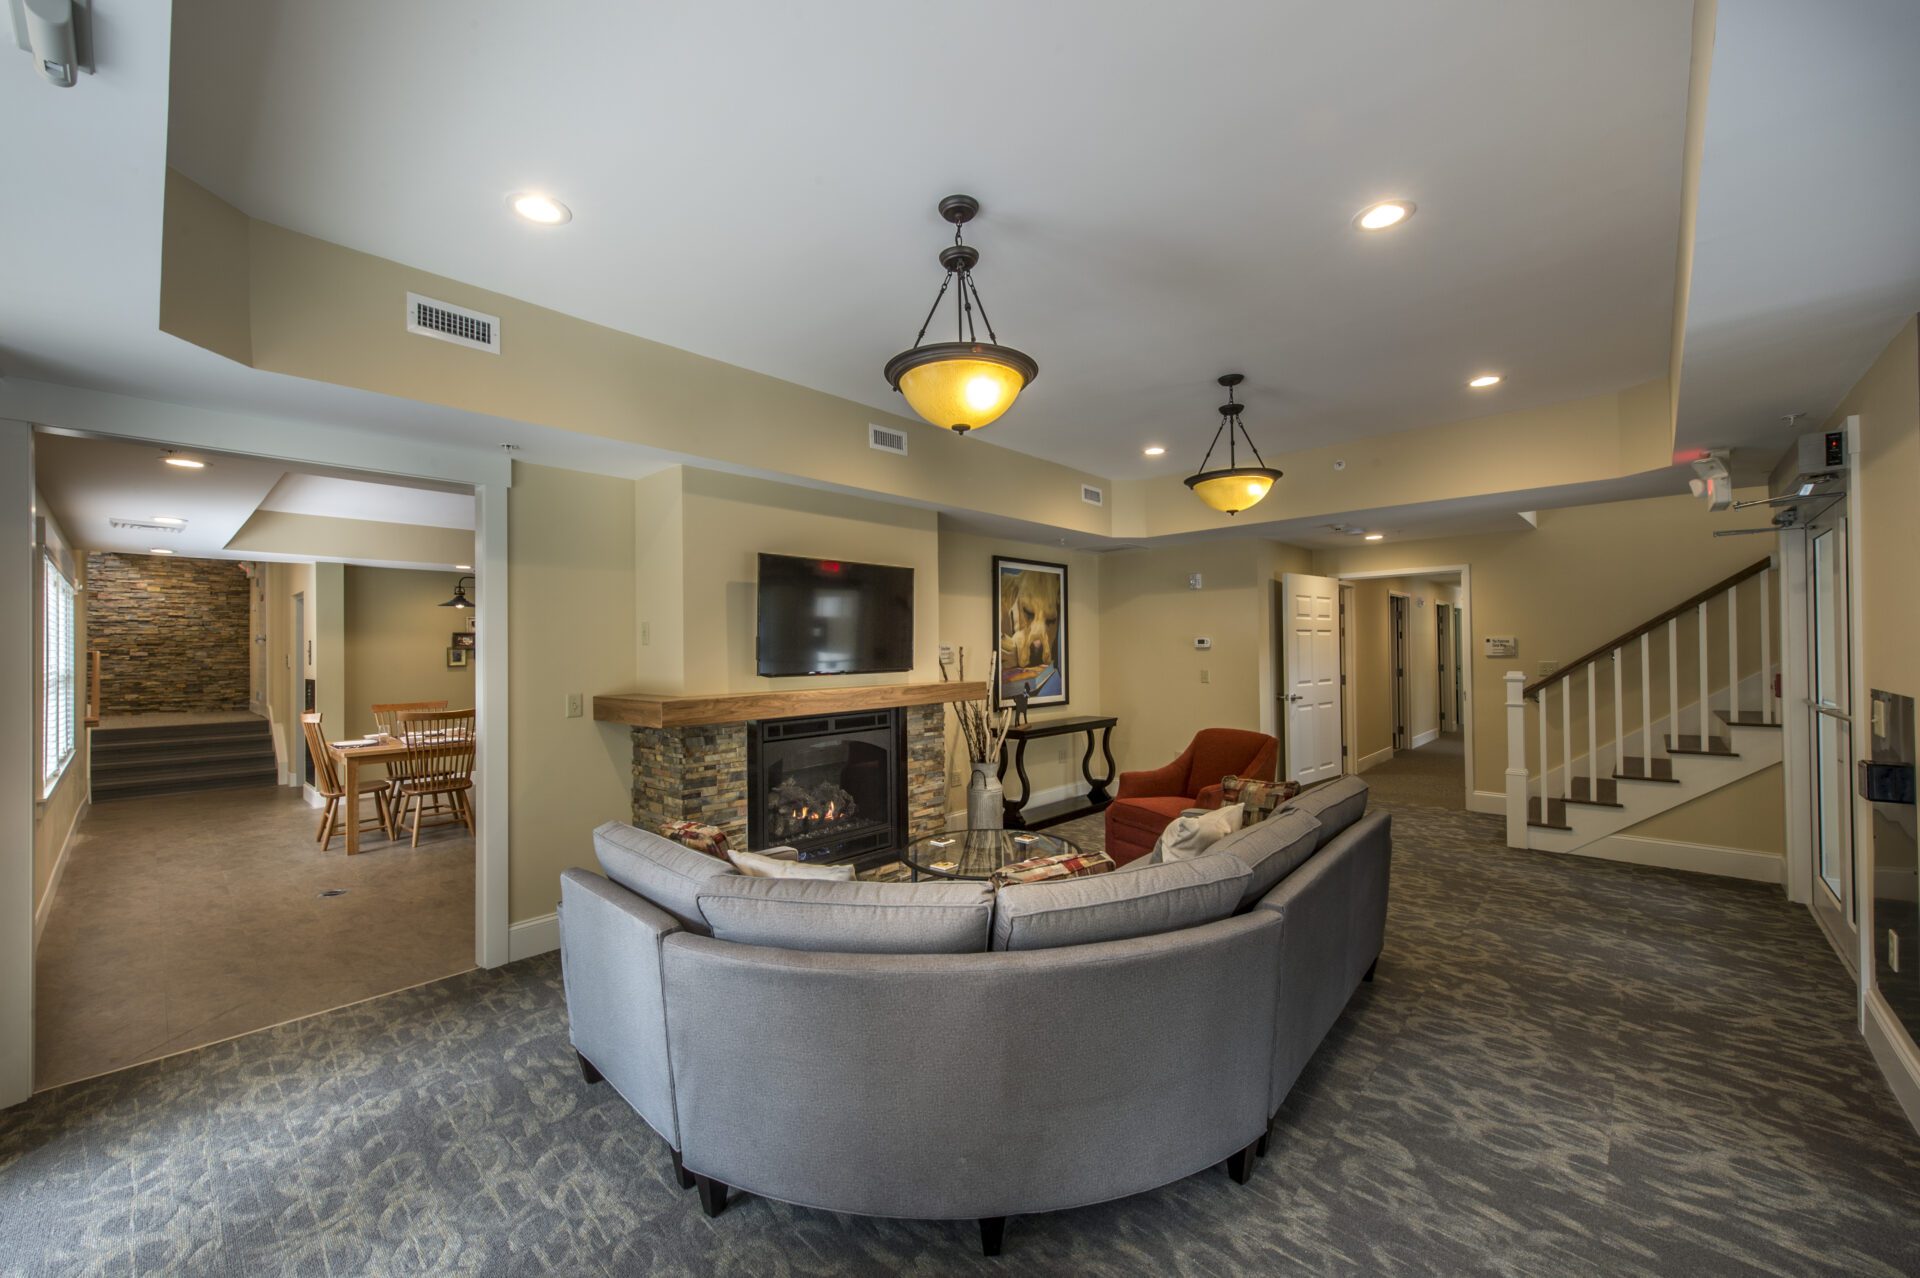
[35,432,472,564]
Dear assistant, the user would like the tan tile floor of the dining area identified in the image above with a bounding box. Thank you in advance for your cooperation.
[35,787,474,1088]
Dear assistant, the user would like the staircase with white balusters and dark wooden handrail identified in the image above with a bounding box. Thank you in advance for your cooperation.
[1507,558,1782,852]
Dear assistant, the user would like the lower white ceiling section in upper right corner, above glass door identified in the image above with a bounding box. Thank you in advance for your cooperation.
[1678,0,1920,458]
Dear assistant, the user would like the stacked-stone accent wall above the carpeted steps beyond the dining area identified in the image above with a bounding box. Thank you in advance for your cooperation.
[86,551,250,714]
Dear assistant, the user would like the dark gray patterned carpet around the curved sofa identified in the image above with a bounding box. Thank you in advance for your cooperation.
[0,808,1920,1276]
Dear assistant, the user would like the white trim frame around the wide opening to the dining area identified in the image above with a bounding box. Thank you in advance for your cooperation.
[0,380,513,1107]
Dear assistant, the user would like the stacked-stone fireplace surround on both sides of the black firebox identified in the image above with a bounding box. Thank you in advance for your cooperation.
[634,706,947,848]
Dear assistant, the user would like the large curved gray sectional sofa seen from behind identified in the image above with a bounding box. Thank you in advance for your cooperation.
[561,777,1392,1255]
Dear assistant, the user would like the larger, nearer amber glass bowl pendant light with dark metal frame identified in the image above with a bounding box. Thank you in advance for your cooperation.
[885,196,1041,434]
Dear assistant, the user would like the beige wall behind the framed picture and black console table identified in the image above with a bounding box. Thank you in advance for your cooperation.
[939,520,1117,812]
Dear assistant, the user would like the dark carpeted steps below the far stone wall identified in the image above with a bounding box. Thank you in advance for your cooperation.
[90,720,278,804]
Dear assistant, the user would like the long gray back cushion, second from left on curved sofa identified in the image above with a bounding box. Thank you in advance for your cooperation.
[699,875,993,954]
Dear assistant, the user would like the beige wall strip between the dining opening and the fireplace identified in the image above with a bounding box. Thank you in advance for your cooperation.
[503,462,634,921]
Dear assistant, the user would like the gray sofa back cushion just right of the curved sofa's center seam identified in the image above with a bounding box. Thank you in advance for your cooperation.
[993,856,1252,950]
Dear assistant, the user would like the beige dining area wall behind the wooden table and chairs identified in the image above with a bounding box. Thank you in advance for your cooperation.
[341,564,474,739]
